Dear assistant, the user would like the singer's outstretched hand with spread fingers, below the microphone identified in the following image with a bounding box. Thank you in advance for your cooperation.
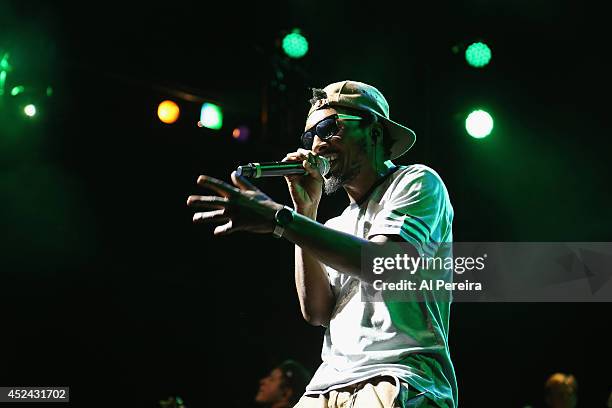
[187,172,283,235]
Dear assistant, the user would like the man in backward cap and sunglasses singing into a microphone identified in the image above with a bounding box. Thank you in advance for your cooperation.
[188,81,457,408]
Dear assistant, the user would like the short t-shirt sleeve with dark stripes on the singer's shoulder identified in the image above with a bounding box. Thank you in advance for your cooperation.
[368,166,452,256]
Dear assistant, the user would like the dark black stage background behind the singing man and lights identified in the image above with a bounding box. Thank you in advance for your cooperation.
[0,0,612,407]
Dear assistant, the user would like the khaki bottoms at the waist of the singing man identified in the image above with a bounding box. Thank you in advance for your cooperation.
[294,377,435,408]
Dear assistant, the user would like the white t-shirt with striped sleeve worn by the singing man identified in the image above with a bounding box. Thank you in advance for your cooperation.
[306,164,457,408]
